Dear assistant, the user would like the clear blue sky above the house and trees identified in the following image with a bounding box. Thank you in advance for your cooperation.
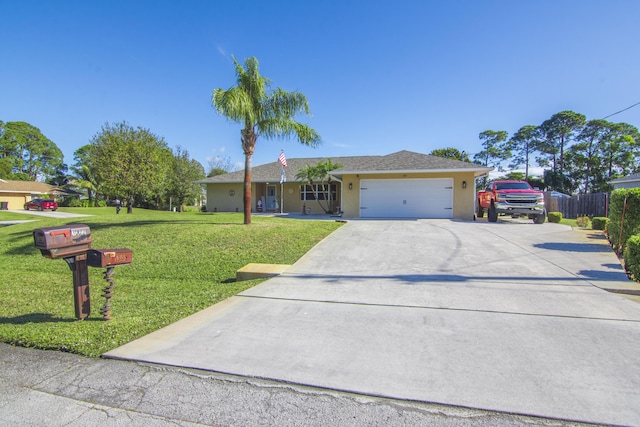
[0,0,640,176]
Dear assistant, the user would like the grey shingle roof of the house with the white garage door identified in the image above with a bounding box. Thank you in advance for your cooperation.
[196,150,492,184]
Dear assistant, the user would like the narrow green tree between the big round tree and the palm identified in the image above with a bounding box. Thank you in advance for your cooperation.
[167,147,204,212]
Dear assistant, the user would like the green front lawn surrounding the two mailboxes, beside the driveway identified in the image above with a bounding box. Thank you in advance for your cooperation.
[0,208,340,357]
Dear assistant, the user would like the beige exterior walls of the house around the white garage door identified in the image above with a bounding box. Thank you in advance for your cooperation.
[202,172,475,221]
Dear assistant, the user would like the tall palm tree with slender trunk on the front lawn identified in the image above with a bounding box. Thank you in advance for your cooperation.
[212,57,321,224]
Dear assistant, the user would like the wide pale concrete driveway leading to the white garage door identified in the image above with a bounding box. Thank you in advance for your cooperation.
[105,220,640,425]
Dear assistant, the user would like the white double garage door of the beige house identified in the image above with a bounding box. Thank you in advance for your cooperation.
[360,178,453,218]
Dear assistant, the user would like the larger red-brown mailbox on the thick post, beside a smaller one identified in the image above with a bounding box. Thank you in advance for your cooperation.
[33,224,91,259]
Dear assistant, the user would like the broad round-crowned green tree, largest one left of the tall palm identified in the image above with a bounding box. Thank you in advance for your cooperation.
[91,122,172,213]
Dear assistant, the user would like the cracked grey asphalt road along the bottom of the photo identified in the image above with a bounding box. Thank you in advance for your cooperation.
[0,344,600,427]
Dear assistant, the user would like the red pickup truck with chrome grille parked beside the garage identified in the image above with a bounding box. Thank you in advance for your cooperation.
[476,181,547,224]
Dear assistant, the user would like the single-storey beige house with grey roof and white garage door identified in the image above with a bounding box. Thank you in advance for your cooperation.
[197,151,492,220]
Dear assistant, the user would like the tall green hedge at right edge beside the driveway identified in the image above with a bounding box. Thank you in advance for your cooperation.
[606,188,640,253]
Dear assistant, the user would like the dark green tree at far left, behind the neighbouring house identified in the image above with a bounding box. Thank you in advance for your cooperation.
[0,122,66,181]
